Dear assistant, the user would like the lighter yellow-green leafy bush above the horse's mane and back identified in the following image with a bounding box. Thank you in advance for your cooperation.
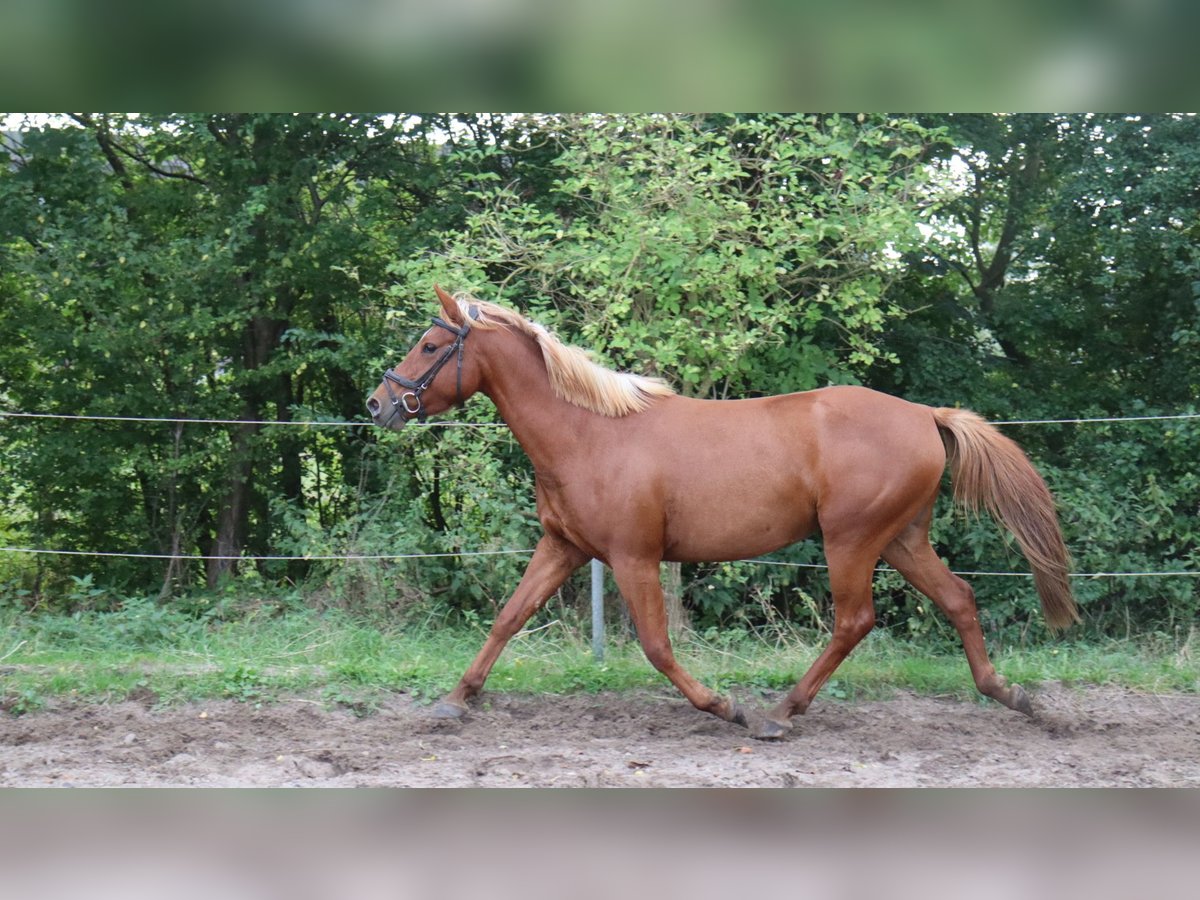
[395,115,932,396]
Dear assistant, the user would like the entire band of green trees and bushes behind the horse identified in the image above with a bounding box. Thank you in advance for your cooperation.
[0,114,1200,648]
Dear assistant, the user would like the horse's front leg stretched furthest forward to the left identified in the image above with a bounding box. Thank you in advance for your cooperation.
[433,534,588,719]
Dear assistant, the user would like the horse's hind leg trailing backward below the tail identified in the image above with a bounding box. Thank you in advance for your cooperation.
[883,510,1033,715]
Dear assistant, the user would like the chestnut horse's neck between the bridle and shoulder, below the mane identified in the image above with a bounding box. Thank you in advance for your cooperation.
[481,332,595,472]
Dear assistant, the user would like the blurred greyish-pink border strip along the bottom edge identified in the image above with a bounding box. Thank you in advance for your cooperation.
[0,790,1200,900]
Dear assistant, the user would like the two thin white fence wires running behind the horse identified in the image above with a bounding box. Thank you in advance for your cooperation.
[0,410,1200,578]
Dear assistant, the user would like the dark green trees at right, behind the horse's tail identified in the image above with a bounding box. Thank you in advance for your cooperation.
[869,115,1200,629]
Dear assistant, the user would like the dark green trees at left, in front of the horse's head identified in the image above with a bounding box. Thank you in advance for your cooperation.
[0,115,458,595]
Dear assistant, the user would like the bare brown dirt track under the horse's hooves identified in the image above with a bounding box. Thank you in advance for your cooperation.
[0,685,1200,787]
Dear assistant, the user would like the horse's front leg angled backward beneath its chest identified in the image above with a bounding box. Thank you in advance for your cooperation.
[612,559,746,726]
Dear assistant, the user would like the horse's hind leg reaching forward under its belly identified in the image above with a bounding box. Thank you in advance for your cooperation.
[754,539,878,738]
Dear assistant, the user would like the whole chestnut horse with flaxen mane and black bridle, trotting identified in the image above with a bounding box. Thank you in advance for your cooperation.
[367,287,1079,738]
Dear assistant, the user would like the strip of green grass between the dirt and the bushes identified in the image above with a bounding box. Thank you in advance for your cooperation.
[0,602,1200,715]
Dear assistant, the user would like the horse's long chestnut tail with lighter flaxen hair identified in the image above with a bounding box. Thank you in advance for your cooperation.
[934,409,1080,631]
